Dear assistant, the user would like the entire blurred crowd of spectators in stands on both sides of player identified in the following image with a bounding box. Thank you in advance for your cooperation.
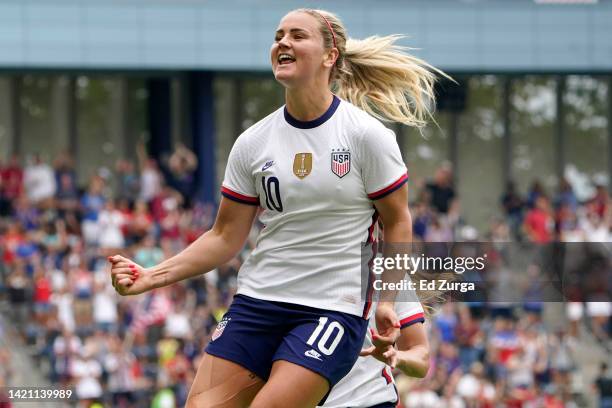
[0,151,612,408]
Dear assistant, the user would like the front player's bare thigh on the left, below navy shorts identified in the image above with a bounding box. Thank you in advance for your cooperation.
[186,353,264,408]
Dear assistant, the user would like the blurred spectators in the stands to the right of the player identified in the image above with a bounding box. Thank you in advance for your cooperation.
[396,166,612,408]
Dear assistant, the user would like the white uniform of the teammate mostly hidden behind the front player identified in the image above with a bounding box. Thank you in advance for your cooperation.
[323,302,425,408]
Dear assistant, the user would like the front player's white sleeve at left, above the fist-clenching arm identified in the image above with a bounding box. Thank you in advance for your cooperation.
[221,137,259,205]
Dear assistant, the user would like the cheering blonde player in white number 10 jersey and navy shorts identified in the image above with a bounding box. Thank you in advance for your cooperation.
[109,9,435,408]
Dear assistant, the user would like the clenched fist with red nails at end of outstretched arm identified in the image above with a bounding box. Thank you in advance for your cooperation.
[108,255,153,296]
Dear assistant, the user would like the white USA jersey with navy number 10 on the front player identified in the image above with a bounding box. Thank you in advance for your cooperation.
[222,96,408,318]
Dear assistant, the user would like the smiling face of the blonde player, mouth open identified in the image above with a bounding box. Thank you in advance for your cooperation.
[270,12,333,88]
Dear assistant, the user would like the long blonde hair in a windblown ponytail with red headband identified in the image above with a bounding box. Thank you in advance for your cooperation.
[295,8,448,128]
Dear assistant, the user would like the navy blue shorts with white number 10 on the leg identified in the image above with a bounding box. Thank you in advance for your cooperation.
[206,295,368,389]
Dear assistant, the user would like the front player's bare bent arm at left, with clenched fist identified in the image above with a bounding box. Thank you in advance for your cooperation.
[109,197,258,295]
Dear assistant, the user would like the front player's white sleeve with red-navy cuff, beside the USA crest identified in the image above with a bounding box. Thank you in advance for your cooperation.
[359,123,408,200]
